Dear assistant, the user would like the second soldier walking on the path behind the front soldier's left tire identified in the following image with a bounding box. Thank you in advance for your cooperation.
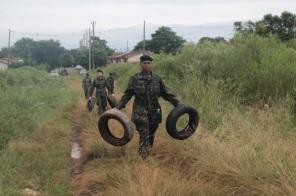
[89,69,111,115]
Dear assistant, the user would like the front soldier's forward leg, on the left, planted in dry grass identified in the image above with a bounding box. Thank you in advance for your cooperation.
[136,122,150,159]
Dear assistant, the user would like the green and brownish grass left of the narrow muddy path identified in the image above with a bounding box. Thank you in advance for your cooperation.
[0,67,76,195]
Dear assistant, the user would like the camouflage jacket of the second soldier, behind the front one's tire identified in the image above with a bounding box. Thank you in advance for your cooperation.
[88,77,111,97]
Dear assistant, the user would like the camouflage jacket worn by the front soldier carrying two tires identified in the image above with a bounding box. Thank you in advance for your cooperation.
[119,72,179,123]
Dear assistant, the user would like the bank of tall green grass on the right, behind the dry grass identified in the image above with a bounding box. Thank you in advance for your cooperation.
[156,35,296,105]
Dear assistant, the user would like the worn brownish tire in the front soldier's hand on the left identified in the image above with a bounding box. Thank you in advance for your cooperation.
[98,108,134,146]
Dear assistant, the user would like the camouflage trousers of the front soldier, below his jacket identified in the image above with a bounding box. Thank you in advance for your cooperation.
[135,121,158,159]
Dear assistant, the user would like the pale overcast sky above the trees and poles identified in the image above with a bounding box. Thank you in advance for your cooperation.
[0,0,296,48]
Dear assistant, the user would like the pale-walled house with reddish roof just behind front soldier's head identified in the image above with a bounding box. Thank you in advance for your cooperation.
[111,50,154,63]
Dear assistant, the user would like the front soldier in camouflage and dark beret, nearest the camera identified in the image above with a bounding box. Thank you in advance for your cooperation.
[117,55,179,159]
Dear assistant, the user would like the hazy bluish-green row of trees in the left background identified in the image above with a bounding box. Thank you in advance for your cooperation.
[0,37,113,70]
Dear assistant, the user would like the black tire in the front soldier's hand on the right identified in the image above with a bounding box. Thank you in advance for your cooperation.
[166,104,199,140]
